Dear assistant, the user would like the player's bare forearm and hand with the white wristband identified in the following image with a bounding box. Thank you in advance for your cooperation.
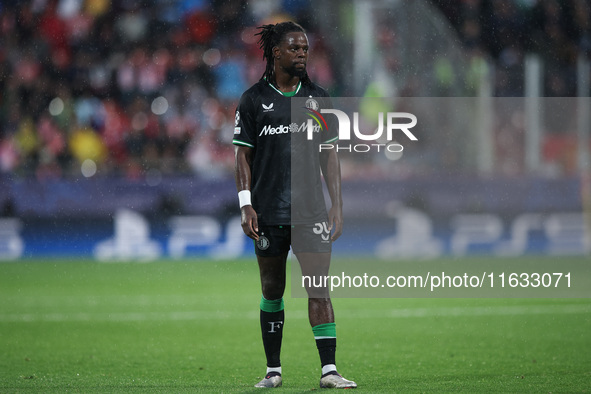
[234,146,259,241]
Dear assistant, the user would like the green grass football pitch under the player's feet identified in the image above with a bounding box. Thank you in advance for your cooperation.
[0,259,591,393]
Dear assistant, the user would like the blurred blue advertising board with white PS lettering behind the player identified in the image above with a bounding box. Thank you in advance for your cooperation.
[0,178,591,261]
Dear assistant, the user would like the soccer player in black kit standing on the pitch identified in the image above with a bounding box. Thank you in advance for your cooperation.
[233,22,357,388]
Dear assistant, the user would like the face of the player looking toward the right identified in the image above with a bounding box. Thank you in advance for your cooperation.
[275,32,309,77]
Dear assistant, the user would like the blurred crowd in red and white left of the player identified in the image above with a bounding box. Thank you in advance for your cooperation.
[0,0,332,180]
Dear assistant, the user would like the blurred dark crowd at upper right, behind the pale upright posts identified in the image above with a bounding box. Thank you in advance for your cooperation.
[433,0,591,177]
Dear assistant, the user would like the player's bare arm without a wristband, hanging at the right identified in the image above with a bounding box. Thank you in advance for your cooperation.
[320,148,343,242]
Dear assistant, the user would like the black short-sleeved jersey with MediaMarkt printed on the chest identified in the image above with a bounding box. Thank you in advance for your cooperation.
[232,79,338,225]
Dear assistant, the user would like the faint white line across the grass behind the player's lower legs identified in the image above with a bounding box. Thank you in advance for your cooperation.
[0,304,591,323]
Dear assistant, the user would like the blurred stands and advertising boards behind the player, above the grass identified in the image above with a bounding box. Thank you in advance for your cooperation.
[0,0,591,260]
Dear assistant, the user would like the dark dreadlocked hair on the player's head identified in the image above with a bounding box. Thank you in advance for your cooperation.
[255,21,311,84]
